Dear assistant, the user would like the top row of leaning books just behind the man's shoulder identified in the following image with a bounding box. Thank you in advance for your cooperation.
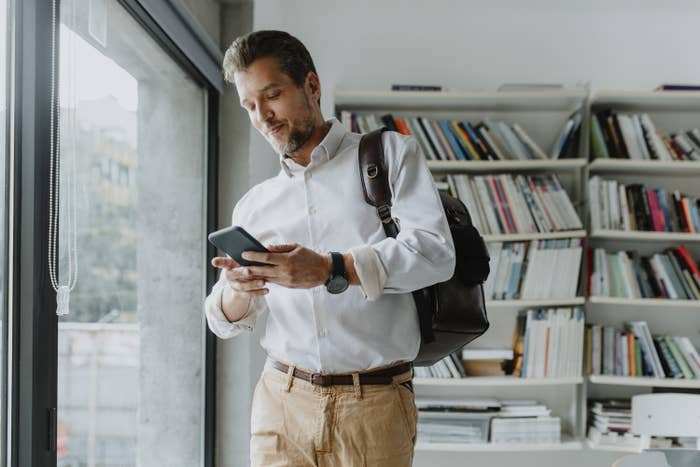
[340,111,581,161]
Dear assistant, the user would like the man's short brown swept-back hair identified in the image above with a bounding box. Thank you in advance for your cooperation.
[223,31,316,87]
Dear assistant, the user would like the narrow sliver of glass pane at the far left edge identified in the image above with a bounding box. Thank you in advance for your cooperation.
[0,0,9,465]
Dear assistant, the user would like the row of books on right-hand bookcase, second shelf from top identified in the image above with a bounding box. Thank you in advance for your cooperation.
[588,175,700,232]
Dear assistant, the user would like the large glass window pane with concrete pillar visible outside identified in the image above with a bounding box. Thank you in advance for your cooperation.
[58,0,206,466]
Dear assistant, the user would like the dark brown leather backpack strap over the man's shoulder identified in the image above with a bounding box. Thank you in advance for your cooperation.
[358,128,399,237]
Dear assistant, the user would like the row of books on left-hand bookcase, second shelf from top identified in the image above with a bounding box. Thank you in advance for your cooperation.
[447,174,583,234]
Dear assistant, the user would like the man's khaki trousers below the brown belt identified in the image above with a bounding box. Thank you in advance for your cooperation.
[250,365,418,467]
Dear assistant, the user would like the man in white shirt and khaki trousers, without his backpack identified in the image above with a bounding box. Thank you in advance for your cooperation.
[205,31,455,467]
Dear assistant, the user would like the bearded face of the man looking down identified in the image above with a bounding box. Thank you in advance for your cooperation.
[234,57,314,154]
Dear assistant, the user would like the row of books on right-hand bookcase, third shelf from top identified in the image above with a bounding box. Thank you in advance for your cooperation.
[589,245,700,300]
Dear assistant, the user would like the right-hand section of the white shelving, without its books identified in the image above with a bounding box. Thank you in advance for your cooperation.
[584,91,700,452]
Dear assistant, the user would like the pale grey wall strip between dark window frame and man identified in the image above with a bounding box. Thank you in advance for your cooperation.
[180,0,264,467]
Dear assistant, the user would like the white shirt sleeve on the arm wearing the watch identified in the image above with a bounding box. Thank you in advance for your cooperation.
[351,133,455,300]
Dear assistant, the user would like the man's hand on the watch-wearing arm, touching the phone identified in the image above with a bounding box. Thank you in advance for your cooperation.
[243,243,332,289]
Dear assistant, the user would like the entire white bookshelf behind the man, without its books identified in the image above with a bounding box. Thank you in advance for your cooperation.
[335,90,700,460]
